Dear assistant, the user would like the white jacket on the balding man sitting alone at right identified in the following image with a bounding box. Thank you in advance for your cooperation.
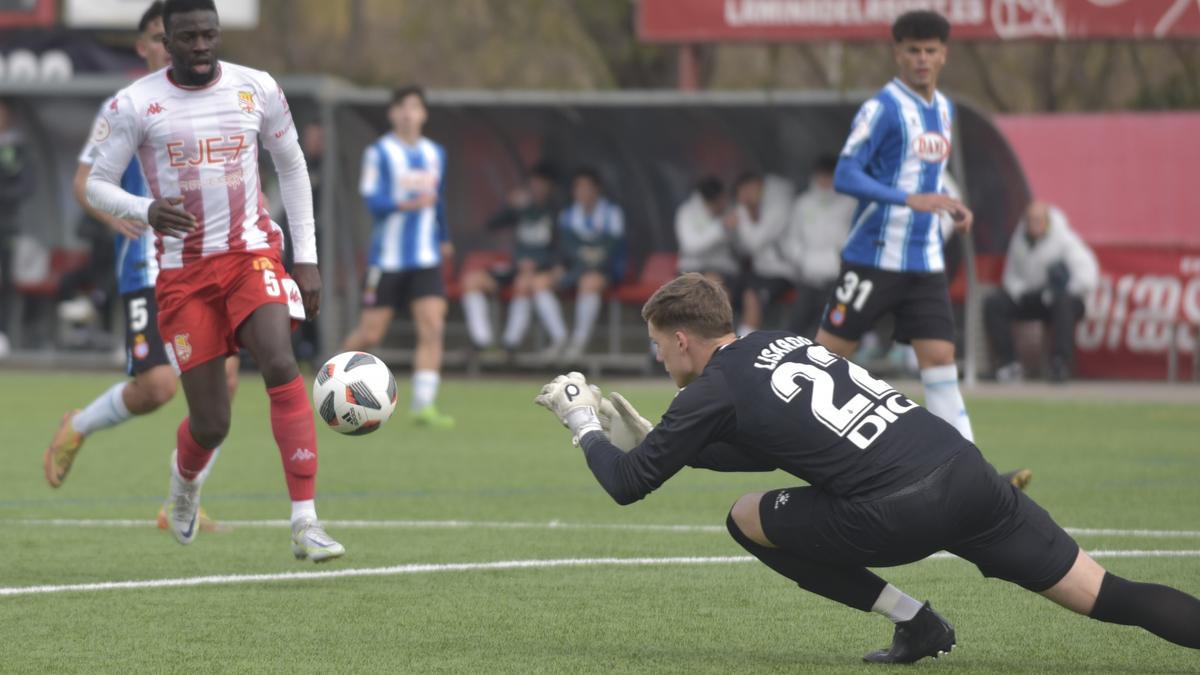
[1003,207,1100,300]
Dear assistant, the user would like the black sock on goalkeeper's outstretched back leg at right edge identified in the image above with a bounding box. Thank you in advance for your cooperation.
[1088,573,1200,649]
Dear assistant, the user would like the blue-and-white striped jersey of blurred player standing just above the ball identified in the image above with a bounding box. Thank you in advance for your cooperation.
[359,133,450,271]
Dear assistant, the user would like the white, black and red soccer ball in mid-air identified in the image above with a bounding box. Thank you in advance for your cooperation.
[312,352,396,436]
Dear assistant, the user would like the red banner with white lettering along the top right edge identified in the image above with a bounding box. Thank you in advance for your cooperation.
[637,0,1200,42]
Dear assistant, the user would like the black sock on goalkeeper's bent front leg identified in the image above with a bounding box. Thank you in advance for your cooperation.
[725,513,888,611]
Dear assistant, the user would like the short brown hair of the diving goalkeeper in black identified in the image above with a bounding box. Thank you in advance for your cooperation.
[642,273,733,338]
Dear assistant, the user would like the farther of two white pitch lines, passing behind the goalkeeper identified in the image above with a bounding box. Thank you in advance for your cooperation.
[7,518,1200,539]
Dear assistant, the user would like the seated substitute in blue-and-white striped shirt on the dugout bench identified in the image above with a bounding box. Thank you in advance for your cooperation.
[558,168,625,362]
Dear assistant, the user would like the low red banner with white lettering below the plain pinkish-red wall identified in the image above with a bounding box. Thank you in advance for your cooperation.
[1075,246,1200,380]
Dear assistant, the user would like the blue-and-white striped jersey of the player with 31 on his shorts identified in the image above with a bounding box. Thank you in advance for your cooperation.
[834,79,954,273]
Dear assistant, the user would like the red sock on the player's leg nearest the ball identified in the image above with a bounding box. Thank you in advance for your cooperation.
[266,375,317,502]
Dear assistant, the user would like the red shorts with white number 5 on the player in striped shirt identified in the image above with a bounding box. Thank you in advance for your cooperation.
[155,250,290,372]
